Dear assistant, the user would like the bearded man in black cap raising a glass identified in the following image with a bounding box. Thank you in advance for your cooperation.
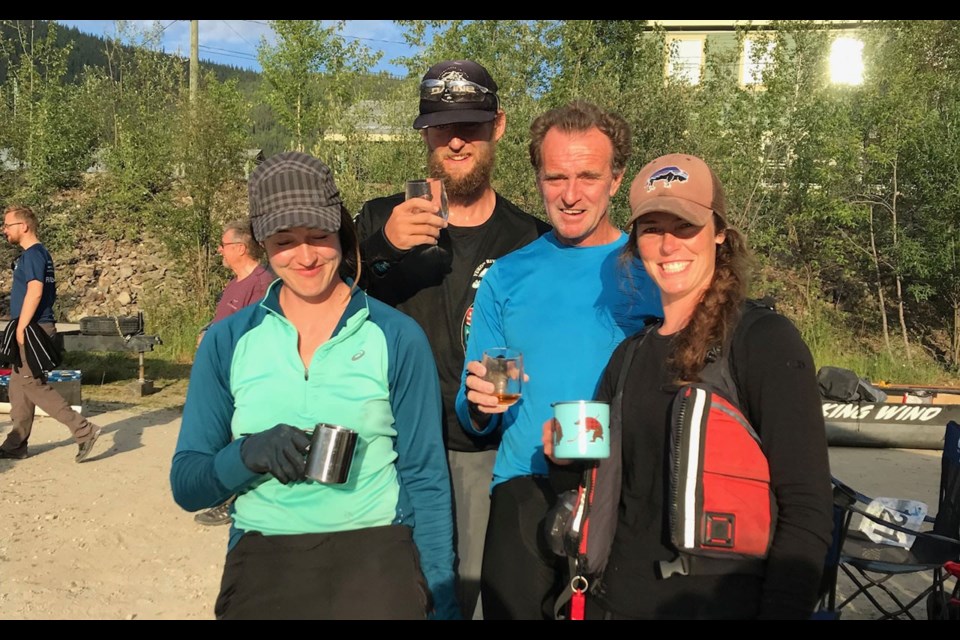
[356,60,550,619]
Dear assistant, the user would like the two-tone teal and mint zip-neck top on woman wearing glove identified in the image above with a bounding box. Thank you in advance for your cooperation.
[170,280,458,618]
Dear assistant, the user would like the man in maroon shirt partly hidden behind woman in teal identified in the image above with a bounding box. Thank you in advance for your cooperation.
[193,220,276,526]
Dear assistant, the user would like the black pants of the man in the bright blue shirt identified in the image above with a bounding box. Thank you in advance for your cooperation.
[480,476,562,620]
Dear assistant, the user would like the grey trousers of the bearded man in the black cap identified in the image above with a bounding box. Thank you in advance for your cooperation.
[447,449,497,620]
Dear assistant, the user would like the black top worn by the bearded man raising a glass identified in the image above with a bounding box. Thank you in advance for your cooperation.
[356,193,551,451]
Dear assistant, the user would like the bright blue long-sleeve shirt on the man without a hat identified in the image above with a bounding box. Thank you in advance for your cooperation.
[457,233,663,490]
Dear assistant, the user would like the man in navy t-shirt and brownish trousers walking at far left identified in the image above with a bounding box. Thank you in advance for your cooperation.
[0,206,100,462]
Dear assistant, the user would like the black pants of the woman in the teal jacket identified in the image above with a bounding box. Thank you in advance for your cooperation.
[214,525,433,620]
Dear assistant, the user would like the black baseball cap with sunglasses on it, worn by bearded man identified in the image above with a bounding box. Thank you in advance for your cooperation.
[413,60,500,129]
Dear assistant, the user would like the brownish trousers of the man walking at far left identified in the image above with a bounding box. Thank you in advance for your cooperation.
[0,324,93,452]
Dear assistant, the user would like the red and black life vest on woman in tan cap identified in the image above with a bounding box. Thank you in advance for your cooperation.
[544,300,776,618]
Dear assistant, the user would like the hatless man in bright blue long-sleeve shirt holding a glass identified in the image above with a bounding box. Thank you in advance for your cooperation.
[457,101,661,620]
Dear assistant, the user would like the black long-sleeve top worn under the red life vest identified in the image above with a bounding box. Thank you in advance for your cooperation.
[598,314,832,619]
